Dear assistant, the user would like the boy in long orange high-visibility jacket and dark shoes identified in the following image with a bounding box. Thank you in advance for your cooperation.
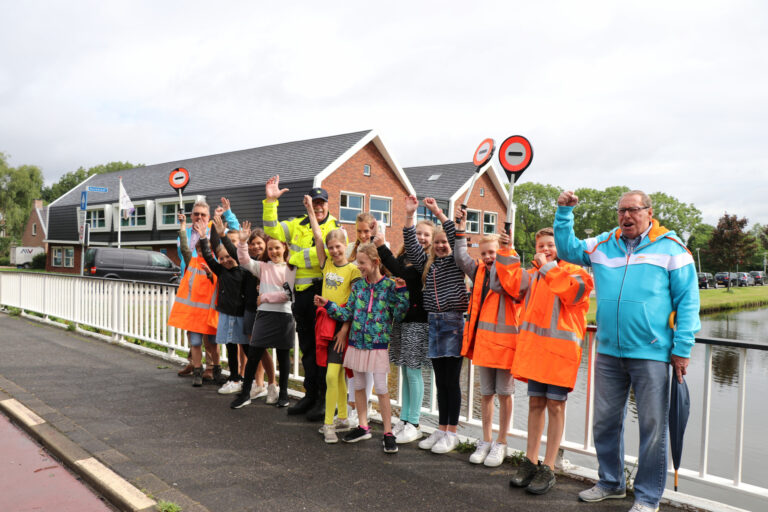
[496,228,594,494]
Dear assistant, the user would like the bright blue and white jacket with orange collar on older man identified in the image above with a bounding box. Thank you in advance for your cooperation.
[554,206,701,362]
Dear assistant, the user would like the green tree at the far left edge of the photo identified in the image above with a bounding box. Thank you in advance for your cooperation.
[0,153,43,241]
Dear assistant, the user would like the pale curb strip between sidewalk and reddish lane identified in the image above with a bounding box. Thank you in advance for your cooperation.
[0,393,157,512]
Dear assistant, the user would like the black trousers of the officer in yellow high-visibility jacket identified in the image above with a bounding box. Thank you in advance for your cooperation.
[293,284,326,400]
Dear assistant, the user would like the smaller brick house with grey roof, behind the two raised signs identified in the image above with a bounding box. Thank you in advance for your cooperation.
[404,162,507,257]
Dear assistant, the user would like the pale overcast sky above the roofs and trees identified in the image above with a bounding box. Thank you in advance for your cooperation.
[0,0,768,224]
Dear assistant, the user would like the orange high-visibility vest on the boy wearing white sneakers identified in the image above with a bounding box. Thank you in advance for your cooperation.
[461,261,521,370]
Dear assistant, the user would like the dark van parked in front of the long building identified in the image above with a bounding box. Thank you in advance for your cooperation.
[83,247,181,283]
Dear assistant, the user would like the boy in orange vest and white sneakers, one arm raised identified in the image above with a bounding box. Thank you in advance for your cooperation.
[454,212,521,467]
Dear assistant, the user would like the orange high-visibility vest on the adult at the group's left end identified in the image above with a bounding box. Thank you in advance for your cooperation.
[168,256,219,334]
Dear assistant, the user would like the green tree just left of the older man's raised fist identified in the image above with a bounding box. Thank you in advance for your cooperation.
[513,182,562,261]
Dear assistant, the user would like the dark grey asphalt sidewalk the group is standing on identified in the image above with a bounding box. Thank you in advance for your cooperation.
[0,314,675,512]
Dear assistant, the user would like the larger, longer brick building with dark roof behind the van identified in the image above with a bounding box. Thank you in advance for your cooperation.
[45,130,415,273]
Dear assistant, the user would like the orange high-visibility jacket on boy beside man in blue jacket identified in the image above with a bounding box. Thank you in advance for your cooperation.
[497,250,594,390]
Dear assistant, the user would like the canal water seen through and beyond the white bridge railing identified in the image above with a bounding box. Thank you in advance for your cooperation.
[424,308,768,511]
